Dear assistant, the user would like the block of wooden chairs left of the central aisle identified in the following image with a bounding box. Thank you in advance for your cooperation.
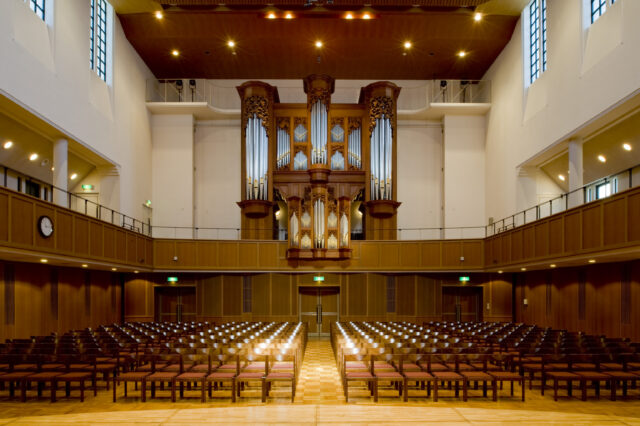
[0,322,307,402]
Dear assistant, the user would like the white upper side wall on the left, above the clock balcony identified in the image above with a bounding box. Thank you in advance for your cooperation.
[0,0,153,218]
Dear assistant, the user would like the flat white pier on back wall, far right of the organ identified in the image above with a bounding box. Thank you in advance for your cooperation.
[444,115,486,238]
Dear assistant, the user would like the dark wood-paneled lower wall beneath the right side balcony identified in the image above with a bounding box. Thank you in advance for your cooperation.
[514,261,640,341]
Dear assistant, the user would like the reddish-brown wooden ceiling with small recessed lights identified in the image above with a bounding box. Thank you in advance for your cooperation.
[118,0,518,80]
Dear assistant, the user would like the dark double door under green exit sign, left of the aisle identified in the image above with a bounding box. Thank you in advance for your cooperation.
[155,287,196,322]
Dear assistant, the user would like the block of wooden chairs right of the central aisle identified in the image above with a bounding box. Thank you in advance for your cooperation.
[331,322,640,402]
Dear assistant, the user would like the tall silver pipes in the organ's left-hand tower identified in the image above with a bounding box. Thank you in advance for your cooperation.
[245,114,269,200]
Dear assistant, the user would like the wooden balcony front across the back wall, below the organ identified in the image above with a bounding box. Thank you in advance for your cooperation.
[153,239,484,272]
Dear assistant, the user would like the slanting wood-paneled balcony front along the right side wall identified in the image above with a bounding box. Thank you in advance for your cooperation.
[484,187,640,268]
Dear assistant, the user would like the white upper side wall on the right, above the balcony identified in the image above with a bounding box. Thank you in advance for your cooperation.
[484,0,640,219]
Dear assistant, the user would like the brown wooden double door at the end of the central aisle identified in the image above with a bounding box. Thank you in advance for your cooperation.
[298,287,340,337]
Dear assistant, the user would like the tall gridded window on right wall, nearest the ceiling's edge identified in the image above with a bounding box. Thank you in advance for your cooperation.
[526,0,547,84]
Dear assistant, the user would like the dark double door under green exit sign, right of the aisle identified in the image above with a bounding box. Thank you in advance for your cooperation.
[442,286,482,322]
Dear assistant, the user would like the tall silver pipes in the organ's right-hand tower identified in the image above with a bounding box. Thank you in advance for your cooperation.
[370,114,393,200]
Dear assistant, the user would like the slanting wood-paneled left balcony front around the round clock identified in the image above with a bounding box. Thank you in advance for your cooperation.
[0,187,153,268]
